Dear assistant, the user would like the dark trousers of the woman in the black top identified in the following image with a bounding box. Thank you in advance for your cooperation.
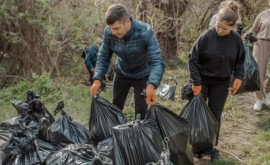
[201,79,230,145]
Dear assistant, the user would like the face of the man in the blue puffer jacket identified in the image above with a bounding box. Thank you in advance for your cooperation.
[108,18,131,38]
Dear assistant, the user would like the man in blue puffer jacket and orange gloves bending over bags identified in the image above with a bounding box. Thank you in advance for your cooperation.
[91,4,164,118]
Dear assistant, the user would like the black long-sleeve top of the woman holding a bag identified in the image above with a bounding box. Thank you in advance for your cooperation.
[188,28,245,86]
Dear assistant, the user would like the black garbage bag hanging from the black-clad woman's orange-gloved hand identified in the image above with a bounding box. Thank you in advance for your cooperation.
[180,95,218,157]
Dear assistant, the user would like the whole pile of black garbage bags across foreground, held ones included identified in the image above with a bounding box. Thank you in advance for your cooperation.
[0,91,217,165]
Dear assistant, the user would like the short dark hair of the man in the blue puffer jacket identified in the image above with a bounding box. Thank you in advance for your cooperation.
[105,4,129,25]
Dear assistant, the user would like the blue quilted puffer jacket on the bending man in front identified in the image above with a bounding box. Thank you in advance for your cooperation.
[94,18,164,88]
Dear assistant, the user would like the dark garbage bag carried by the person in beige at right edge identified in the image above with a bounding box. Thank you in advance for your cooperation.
[231,40,260,94]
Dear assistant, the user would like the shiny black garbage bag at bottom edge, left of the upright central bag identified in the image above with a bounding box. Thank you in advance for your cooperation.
[46,144,112,165]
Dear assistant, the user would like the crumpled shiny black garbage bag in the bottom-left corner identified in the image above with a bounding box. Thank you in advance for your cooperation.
[4,125,58,165]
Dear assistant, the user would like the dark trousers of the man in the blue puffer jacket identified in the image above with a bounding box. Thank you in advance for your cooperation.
[112,73,148,119]
